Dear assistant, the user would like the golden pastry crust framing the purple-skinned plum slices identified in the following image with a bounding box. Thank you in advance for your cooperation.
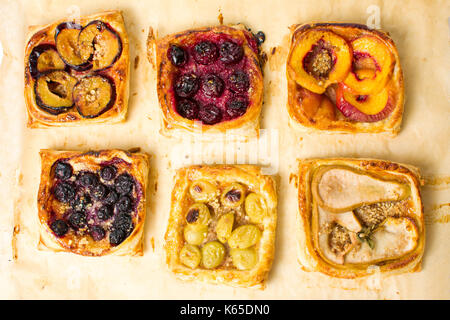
[24,10,130,128]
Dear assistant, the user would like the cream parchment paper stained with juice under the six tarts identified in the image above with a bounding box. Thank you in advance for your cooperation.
[0,0,450,299]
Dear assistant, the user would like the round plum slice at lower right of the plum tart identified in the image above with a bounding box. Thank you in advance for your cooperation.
[73,75,115,118]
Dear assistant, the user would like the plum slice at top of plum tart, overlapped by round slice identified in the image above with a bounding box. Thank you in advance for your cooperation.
[55,22,92,71]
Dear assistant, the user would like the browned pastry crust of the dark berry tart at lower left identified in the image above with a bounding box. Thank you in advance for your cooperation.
[38,149,149,256]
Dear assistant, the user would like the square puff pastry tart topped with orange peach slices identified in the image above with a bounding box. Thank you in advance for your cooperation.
[286,23,403,135]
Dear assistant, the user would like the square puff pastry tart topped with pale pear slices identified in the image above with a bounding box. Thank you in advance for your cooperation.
[298,159,425,278]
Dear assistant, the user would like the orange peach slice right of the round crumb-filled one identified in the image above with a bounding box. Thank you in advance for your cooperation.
[344,36,394,95]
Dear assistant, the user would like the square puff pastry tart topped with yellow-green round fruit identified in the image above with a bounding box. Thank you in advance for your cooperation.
[165,165,277,289]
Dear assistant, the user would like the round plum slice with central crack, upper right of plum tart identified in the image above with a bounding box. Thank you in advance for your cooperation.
[78,20,122,70]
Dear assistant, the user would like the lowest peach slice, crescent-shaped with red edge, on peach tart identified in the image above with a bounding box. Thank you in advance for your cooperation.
[336,83,394,122]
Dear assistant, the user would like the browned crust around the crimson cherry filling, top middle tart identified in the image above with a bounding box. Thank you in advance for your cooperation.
[152,25,264,140]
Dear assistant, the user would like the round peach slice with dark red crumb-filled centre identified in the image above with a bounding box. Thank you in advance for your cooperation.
[288,29,352,94]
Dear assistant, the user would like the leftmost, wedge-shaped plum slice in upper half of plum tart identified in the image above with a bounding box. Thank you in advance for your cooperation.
[28,44,66,78]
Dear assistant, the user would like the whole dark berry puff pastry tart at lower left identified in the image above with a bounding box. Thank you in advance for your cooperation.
[38,150,149,256]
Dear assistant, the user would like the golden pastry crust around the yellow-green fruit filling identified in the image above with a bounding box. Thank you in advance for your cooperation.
[165,165,277,289]
